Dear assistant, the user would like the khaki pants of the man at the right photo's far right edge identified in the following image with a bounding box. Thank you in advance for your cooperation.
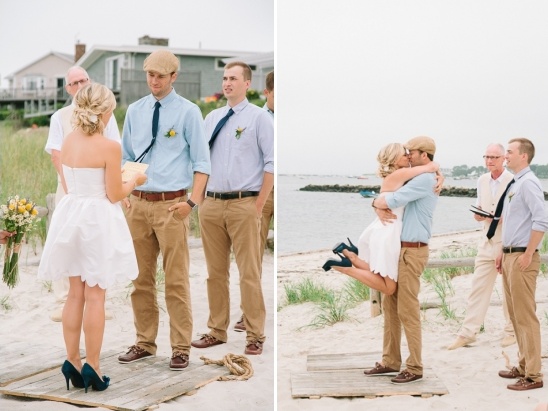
[502,252,542,381]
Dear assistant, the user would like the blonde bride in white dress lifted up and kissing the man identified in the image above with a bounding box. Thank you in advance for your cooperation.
[331,143,441,295]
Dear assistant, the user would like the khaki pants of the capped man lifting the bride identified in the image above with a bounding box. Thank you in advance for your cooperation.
[382,247,428,375]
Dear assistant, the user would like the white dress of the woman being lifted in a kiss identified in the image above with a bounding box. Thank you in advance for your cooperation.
[358,193,404,281]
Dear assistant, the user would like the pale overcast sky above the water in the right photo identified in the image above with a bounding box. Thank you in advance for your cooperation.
[276,0,548,175]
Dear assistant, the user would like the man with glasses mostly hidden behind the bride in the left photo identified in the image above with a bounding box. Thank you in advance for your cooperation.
[45,66,121,321]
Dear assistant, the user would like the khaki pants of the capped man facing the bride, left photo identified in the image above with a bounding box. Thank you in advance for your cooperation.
[126,195,192,354]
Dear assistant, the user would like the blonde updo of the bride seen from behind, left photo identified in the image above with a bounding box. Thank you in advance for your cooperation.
[72,83,116,136]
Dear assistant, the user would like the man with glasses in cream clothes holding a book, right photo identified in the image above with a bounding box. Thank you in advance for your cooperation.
[447,144,516,350]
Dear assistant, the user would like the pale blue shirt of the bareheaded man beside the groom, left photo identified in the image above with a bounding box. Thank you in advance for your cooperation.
[205,99,274,193]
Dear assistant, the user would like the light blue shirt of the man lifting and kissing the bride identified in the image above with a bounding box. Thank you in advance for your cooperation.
[385,173,438,243]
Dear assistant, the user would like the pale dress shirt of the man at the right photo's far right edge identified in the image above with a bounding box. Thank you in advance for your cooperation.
[502,167,548,247]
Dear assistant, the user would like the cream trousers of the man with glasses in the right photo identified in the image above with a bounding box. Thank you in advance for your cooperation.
[459,236,514,338]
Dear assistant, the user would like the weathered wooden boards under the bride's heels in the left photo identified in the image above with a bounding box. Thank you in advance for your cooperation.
[0,347,230,411]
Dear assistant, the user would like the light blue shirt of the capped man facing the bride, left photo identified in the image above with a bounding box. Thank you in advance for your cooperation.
[122,89,211,192]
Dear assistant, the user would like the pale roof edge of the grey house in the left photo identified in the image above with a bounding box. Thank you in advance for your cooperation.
[76,44,264,68]
